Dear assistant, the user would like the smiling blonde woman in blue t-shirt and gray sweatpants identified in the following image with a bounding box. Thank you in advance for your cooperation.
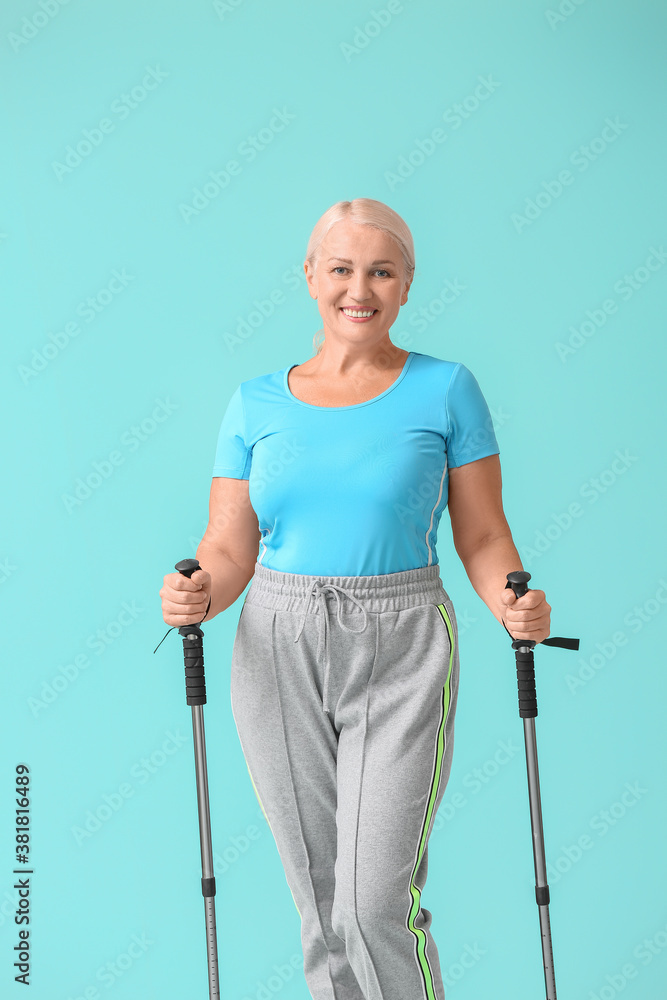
[160,198,551,1000]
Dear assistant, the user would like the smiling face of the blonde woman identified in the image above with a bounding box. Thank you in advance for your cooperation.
[304,220,411,343]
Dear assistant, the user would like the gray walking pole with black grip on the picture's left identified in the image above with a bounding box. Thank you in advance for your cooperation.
[174,559,220,1000]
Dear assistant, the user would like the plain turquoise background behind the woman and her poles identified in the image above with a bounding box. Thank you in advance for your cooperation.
[0,0,667,1000]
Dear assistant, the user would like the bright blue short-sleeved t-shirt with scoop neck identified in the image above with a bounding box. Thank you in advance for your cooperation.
[213,351,500,576]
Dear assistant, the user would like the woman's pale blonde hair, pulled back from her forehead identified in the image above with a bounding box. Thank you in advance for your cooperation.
[306,198,415,355]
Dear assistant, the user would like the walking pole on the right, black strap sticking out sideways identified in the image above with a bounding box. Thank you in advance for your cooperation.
[503,570,579,1000]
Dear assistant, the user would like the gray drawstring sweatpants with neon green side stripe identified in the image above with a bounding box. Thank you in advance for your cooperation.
[231,563,459,1000]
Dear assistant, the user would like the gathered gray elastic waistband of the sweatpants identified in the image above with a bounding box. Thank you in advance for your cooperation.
[244,563,451,612]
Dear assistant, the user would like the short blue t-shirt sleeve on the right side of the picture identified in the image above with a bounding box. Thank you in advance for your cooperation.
[445,364,500,469]
